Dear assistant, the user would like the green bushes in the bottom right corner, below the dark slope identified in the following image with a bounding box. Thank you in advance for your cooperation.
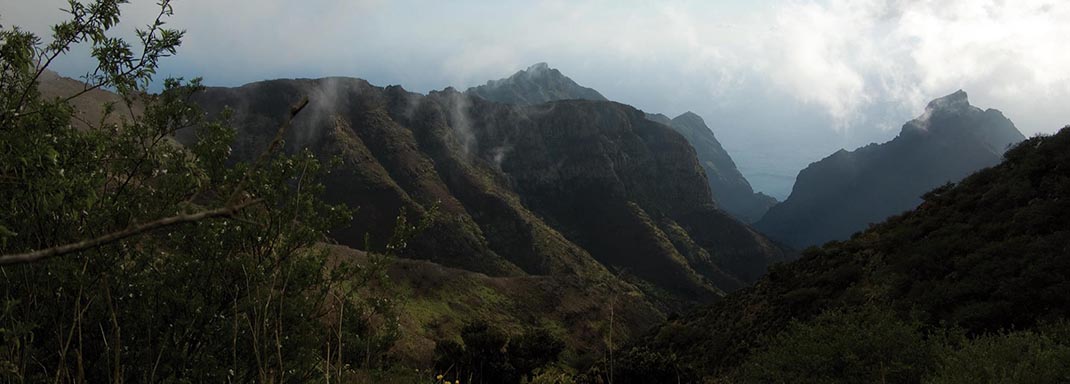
[732,306,1070,383]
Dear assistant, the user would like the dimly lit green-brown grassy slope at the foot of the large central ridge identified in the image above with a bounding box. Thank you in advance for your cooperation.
[328,245,664,367]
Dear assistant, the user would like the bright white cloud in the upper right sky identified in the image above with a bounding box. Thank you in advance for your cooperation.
[754,0,1070,132]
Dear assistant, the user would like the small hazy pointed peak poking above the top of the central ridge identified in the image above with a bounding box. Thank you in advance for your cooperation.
[464,63,606,104]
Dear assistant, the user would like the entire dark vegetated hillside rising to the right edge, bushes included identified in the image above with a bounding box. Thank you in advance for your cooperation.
[633,128,1070,383]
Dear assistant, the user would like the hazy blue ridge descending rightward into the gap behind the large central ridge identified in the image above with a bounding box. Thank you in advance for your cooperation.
[647,112,777,222]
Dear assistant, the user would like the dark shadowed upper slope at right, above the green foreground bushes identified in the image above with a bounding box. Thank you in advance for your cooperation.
[637,126,1070,382]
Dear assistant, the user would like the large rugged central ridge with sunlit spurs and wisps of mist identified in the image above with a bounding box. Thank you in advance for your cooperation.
[185,78,785,306]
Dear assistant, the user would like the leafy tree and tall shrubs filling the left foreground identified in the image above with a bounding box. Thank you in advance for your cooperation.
[0,0,418,383]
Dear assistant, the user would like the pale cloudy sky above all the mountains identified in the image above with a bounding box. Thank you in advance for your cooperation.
[0,0,1070,199]
